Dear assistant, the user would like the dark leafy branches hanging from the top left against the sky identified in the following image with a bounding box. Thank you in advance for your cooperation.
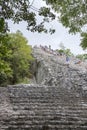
[0,0,55,33]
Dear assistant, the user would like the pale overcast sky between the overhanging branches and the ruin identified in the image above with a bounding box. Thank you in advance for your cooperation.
[8,0,85,55]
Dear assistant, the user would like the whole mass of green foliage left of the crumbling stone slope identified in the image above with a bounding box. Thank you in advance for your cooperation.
[0,31,33,85]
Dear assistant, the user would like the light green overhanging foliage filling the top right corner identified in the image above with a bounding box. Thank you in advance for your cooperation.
[45,0,87,33]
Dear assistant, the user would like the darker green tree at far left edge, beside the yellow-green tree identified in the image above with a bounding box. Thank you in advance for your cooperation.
[0,34,12,85]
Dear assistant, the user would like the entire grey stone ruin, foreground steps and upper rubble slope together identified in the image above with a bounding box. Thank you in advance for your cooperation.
[0,48,87,130]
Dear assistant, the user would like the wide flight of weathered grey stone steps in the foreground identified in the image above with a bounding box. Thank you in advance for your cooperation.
[0,84,87,130]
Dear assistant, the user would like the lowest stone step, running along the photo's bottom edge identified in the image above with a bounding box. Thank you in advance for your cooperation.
[2,124,87,130]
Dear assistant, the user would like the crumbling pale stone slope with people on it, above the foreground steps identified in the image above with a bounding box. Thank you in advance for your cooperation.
[34,49,87,90]
